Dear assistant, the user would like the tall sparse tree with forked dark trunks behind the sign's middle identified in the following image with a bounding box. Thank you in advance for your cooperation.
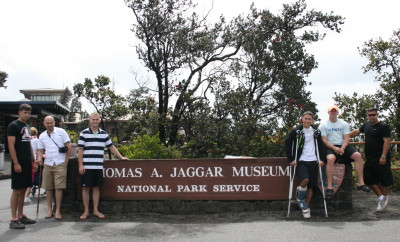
[125,0,240,145]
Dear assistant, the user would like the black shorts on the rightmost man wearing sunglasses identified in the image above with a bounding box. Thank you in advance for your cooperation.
[364,161,393,187]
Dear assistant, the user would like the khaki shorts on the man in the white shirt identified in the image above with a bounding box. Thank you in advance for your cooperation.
[42,162,68,189]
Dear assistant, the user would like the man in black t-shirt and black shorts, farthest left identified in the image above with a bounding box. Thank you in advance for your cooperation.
[7,104,37,229]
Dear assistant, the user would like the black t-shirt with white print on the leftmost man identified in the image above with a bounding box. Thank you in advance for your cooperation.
[7,120,32,160]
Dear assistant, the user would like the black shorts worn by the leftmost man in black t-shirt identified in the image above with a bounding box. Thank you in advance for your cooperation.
[11,159,32,189]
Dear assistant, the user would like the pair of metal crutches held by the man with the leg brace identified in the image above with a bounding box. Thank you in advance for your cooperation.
[287,133,328,217]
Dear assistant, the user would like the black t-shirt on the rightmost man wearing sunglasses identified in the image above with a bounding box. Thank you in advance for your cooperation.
[360,121,390,161]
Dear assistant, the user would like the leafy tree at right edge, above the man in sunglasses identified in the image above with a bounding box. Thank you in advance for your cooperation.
[359,29,400,140]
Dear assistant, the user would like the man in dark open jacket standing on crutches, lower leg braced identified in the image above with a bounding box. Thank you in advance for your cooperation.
[285,111,326,218]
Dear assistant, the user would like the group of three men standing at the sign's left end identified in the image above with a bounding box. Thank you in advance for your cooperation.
[7,104,127,229]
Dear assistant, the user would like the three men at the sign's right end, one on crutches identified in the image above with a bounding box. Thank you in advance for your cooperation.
[285,105,393,218]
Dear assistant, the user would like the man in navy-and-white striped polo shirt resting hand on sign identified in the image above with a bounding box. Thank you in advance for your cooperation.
[78,113,128,220]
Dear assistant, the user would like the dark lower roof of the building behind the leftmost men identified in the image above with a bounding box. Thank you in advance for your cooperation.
[0,100,70,115]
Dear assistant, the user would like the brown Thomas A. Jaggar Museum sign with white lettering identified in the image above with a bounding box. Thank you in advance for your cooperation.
[78,158,300,200]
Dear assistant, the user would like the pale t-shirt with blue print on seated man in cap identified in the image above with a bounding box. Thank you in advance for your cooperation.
[319,119,350,145]
